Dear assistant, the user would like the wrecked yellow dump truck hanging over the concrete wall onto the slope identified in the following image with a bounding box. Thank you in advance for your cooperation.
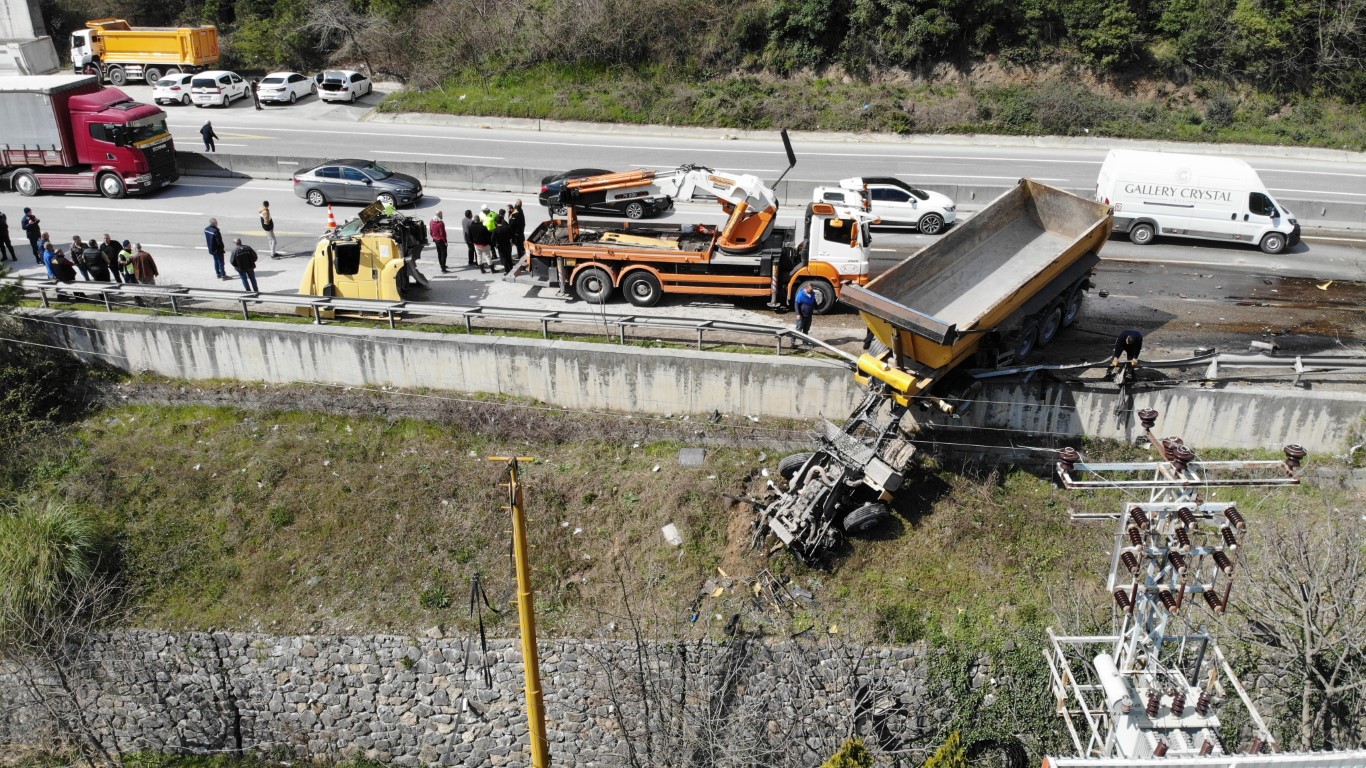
[759,179,1112,560]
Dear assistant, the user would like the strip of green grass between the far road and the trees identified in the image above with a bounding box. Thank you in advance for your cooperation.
[380,66,1366,152]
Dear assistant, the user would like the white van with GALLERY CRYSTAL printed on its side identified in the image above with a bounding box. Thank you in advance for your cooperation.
[1096,149,1299,253]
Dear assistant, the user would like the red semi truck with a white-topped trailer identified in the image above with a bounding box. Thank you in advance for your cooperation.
[0,75,179,198]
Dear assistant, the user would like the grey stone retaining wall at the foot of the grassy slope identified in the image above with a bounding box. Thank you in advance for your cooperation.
[0,631,947,767]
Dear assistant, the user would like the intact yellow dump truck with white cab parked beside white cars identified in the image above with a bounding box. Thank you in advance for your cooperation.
[71,19,219,86]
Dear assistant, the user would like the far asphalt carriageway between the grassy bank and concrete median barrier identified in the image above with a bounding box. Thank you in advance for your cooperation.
[112,86,1366,205]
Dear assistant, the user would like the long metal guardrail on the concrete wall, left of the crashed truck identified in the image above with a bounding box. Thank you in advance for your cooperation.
[0,276,830,361]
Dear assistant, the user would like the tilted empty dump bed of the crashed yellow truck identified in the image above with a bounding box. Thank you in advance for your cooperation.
[841,179,1111,370]
